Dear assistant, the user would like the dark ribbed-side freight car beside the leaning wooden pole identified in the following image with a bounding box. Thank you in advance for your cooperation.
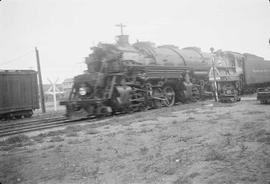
[0,70,39,119]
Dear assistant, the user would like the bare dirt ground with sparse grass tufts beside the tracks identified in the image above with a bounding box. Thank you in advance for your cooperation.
[0,99,270,184]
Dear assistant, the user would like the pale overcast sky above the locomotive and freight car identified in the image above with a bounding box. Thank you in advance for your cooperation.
[0,0,270,83]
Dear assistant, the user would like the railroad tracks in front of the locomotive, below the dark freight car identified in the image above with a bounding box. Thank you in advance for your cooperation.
[0,117,91,137]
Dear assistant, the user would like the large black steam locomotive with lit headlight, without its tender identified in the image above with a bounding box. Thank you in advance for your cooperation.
[60,35,268,117]
